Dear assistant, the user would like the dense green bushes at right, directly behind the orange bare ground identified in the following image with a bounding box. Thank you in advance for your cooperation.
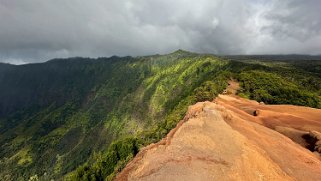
[238,71,321,108]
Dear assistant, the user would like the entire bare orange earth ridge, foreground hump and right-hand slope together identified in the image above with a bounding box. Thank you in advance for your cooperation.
[116,81,321,181]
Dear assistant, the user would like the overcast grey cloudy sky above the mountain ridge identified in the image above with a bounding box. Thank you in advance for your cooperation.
[0,0,321,64]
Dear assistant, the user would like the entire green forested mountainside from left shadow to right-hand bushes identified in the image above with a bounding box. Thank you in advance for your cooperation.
[0,50,321,180]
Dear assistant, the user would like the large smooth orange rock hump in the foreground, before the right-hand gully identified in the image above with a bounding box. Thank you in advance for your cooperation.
[116,101,321,180]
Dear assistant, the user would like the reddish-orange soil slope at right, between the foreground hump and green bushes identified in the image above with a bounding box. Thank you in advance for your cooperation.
[215,95,321,147]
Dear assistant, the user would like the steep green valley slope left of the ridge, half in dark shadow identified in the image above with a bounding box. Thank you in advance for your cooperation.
[0,51,227,180]
